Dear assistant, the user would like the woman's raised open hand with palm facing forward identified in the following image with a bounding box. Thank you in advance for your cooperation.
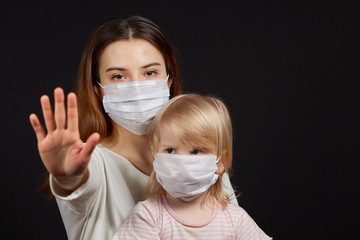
[30,88,100,191]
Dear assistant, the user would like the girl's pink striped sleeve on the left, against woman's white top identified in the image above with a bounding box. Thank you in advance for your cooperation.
[113,202,160,240]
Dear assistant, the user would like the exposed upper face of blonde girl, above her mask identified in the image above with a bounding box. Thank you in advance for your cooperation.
[157,125,213,155]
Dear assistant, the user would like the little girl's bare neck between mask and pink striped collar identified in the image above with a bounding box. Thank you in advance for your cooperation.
[165,193,217,226]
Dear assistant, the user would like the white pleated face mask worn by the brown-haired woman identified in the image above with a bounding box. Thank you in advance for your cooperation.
[99,75,170,135]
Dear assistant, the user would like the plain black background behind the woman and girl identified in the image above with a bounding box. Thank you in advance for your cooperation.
[0,0,360,239]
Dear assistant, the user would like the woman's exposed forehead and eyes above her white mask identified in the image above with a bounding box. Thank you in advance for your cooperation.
[99,39,171,86]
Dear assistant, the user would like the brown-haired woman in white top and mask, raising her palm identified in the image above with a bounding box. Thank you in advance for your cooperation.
[30,16,236,239]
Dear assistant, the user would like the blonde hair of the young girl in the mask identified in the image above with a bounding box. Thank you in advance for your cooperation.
[147,94,232,207]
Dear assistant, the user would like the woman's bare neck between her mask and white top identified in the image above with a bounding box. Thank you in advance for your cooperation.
[101,123,154,175]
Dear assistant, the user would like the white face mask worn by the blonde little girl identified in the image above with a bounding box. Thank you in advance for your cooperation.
[153,153,219,201]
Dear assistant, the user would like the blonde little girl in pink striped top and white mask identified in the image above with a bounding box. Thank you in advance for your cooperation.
[113,94,270,240]
